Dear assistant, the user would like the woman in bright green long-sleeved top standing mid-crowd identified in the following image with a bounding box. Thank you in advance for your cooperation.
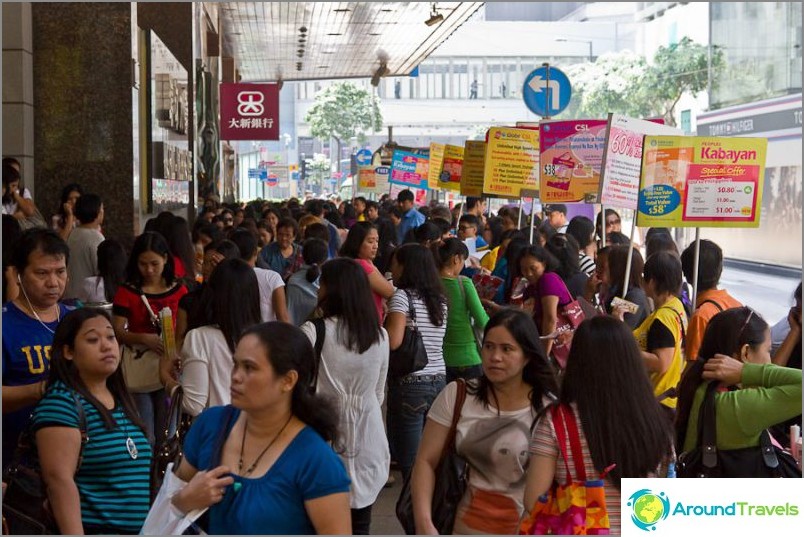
[433,238,489,384]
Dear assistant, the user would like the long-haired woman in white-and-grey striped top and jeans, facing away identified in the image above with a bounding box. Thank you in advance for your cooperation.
[382,243,447,477]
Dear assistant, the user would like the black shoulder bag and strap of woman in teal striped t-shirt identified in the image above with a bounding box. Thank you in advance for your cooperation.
[3,391,89,535]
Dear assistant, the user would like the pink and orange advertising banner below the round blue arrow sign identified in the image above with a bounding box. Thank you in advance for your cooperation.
[539,119,608,203]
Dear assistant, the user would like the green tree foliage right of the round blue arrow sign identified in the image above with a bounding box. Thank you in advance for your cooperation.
[562,37,725,125]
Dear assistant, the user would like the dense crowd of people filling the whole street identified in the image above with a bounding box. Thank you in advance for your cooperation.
[2,157,802,534]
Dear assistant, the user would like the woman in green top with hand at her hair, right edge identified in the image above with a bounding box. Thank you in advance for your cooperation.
[676,308,801,453]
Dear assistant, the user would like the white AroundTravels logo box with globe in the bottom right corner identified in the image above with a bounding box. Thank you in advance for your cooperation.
[622,479,804,536]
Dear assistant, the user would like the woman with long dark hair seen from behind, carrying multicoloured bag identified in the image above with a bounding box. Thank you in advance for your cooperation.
[525,316,673,534]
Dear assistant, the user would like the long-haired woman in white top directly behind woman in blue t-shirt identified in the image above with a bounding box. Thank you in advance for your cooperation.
[171,255,261,416]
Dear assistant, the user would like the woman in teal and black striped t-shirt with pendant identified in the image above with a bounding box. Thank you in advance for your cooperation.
[31,308,151,535]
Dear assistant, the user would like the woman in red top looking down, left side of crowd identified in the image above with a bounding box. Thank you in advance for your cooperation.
[112,232,187,442]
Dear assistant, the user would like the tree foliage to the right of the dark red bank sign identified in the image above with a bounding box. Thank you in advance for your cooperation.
[304,82,382,145]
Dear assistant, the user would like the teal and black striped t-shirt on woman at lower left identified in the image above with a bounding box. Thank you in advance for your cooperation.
[31,382,151,533]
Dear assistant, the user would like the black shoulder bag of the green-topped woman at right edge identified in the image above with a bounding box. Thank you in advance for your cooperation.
[676,381,801,478]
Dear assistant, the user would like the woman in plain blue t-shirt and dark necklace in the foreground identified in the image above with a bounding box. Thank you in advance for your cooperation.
[173,322,352,535]
